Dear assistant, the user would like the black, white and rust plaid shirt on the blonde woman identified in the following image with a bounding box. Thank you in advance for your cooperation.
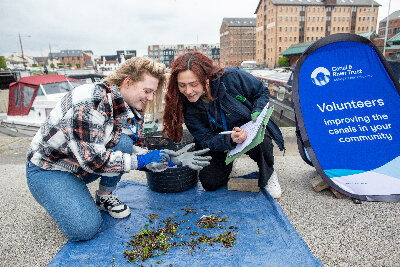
[27,83,142,177]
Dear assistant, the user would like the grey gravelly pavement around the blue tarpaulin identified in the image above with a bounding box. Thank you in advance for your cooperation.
[0,128,400,266]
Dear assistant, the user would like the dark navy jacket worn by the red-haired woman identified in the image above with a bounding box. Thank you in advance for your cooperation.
[183,67,284,151]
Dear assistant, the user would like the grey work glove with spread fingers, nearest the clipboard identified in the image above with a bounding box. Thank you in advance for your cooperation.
[164,143,211,171]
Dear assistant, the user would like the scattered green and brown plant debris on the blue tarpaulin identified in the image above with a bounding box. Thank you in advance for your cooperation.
[123,207,238,263]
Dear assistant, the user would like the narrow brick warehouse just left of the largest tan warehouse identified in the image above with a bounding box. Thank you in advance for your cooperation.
[219,18,256,67]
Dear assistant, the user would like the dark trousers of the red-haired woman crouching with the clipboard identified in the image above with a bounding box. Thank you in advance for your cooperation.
[199,131,274,191]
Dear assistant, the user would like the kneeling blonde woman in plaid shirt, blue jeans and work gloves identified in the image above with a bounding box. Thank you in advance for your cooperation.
[26,58,210,241]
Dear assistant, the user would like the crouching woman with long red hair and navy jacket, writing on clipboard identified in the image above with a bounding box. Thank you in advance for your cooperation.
[163,52,284,198]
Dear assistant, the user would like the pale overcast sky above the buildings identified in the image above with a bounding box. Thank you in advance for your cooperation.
[0,0,400,57]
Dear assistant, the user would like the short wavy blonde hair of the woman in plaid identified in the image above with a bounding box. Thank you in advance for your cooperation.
[105,57,167,120]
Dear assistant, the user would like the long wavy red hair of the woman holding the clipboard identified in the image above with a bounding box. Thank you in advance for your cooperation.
[163,52,223,142]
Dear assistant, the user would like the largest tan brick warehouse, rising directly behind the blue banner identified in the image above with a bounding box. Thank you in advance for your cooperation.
[255,0,380,68]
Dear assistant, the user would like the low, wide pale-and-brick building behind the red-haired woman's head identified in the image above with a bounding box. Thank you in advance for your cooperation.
[147,44,220,67]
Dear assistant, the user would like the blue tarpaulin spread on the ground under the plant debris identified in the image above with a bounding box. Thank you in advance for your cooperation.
[49,180,322,266]
